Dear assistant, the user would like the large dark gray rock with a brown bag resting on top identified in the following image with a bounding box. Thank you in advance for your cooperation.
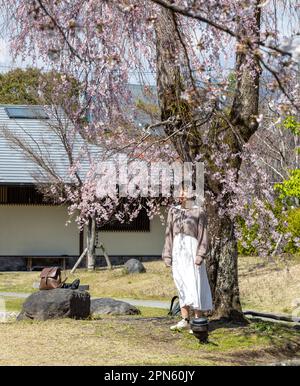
[17,288,91,320]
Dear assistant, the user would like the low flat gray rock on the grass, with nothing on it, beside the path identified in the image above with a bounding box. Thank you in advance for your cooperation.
[91,298,141,316]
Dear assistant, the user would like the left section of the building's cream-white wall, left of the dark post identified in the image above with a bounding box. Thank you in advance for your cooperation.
[0,205,79,256]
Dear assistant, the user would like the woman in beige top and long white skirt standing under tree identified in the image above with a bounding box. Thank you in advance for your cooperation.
[162,192,213,330]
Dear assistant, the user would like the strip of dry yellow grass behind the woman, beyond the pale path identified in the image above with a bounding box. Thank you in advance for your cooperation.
[0,256,300,313]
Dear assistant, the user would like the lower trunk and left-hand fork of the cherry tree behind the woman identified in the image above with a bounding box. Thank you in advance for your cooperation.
[156,10,245,321]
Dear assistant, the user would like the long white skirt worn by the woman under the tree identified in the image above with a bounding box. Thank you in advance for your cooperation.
[172,233,213,311]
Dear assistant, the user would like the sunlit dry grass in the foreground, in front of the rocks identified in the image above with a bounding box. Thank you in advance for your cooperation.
[0,310,300,366]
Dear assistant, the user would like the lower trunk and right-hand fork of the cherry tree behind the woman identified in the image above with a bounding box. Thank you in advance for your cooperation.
[207,4,261,321]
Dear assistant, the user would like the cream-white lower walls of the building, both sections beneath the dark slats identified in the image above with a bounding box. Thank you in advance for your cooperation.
[0,205,164,256]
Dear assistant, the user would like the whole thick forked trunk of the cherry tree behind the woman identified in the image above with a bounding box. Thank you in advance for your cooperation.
[156,4,260,321]
